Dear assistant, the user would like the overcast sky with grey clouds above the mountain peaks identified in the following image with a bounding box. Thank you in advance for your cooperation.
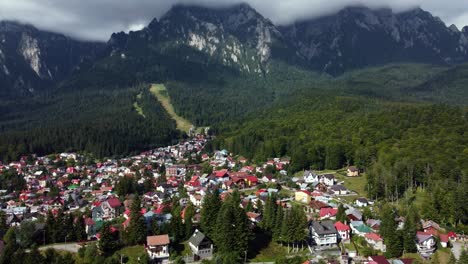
[0,0,468,41]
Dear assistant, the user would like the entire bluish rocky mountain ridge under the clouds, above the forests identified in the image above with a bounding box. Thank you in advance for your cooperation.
[0,4,468,95]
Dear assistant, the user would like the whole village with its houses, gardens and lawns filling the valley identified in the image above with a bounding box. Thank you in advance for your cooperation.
[0,134,466,264]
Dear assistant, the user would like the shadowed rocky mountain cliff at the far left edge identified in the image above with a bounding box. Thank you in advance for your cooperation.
[0,21,104,96]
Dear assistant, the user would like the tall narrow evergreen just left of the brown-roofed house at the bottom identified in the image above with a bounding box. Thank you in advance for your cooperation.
[126,195,147,245]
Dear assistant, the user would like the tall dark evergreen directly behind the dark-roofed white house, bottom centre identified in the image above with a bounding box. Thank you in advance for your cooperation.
[200,191,221,238]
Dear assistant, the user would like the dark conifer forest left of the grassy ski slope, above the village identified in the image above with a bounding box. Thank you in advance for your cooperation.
[0,86,181,161]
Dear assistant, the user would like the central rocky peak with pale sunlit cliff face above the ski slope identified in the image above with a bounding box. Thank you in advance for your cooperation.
[110,4,292,74]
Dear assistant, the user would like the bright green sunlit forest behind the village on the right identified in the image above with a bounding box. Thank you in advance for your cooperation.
[213,97,468,225]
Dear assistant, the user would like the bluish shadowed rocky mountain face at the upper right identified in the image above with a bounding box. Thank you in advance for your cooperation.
[281,7,468,75]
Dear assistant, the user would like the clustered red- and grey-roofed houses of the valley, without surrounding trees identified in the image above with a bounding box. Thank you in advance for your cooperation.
[0,135,464,263]
